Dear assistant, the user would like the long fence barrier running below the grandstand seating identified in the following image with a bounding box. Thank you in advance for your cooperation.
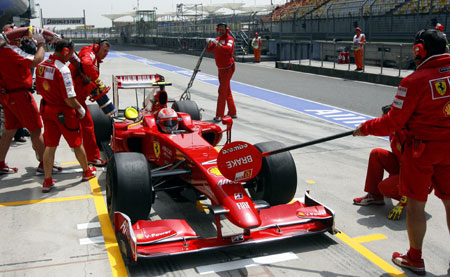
[62,11,450,41]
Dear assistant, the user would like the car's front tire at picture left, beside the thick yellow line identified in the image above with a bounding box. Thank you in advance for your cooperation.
[106,152,153,224]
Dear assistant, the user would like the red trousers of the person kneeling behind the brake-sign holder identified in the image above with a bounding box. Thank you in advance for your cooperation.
[364,148,400,200]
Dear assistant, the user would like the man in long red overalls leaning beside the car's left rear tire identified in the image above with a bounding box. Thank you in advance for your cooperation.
[69,40,111,166]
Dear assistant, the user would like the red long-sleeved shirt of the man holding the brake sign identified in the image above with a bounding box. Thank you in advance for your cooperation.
[361,54,450,140]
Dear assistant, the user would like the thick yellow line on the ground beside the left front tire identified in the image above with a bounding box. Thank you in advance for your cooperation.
[89,178,128,277]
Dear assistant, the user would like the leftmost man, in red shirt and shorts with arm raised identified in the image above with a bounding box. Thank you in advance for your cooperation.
[0,25,45,174]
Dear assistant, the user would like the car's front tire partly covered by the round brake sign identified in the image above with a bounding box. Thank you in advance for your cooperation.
[246,141,297,206]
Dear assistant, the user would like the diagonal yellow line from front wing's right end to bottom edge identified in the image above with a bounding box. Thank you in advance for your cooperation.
[336,231,407,276]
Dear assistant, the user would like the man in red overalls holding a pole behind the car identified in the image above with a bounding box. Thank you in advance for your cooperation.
[206,23,237,122]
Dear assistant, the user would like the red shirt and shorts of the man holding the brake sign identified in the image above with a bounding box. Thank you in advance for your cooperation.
[361,54,450,201]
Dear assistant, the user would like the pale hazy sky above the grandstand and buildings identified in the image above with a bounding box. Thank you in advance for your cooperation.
[31,0,286,28]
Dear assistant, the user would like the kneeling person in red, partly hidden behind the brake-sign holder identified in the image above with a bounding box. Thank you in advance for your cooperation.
[353,105,408,220]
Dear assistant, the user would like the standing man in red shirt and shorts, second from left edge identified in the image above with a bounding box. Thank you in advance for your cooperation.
[36,39,96,192]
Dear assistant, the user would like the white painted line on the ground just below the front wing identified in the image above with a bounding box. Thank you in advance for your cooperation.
[196,252,298,275]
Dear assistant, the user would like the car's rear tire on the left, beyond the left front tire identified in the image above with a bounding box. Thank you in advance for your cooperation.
[87,104,112,150]
